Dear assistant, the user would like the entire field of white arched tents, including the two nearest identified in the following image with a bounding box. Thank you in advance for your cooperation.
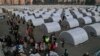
[2,7,100,45]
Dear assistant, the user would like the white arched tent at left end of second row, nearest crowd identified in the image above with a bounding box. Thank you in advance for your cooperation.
[42,22,61,33]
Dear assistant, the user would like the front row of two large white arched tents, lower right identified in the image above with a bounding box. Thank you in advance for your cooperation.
[60,23,100,45]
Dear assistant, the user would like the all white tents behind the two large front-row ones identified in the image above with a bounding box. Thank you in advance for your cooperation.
[6,7,100,33]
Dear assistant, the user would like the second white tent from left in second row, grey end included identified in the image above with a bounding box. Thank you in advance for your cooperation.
[62,19,79,28]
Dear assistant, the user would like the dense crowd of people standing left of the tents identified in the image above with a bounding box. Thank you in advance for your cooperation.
[0,13,63,56]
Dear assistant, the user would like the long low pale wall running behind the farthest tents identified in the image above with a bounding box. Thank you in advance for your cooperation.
[0,5,95,9]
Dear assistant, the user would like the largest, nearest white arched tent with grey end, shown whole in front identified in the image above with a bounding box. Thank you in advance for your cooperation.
[60,27,88,45]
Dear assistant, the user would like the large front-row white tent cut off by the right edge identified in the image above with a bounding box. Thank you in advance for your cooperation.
[84,23,100,36]
